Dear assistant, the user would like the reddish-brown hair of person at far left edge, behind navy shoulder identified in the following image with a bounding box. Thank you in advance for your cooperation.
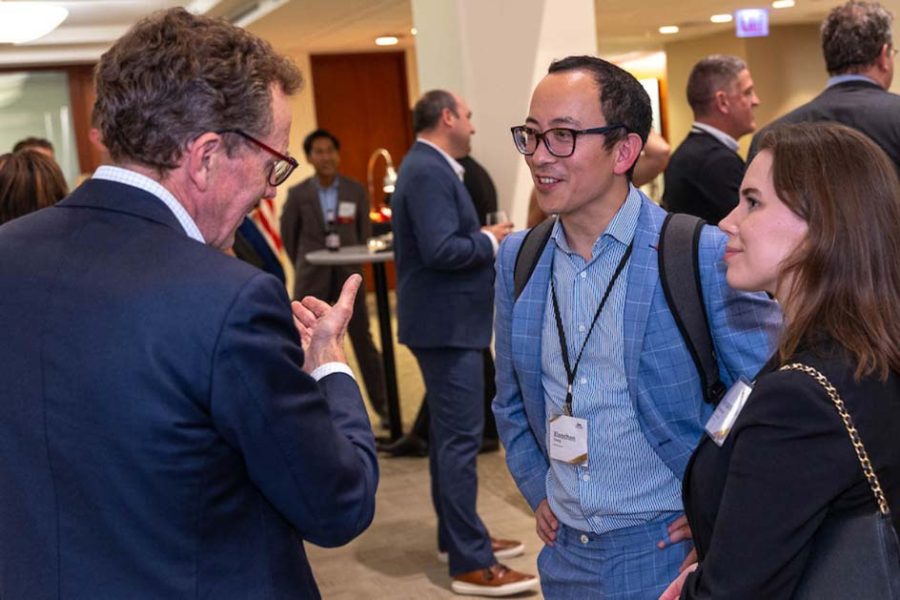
[0,150,68,223]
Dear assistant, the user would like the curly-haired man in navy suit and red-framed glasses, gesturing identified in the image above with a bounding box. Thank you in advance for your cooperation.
[0,9,378,600]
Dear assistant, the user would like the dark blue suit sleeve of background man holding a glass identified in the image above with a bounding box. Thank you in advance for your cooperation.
[406,171,494,271]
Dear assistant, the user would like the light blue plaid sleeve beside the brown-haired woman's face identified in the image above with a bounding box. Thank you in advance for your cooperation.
[700,227,782,385]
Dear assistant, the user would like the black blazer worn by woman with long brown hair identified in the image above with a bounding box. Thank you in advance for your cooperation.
[681,350,900,600]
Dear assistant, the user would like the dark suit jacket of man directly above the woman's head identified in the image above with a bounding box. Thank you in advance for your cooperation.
[747,81,900,170]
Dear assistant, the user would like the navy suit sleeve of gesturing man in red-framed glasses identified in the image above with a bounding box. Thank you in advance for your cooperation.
[211,275,378,546]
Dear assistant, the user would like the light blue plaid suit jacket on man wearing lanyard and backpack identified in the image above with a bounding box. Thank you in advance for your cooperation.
[494,195,781,592]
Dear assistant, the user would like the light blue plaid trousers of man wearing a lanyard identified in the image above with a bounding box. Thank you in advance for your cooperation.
[538,514,693,600]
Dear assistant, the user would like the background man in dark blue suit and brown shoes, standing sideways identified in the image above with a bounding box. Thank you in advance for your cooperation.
[391,90,537,596]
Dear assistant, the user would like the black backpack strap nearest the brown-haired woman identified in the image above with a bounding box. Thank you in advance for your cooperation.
[659,214,725,404]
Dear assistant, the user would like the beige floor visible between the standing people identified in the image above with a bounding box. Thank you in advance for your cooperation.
[307,294,543,600]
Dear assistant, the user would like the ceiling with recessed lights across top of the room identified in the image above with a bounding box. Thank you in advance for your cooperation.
[0,0,860,69]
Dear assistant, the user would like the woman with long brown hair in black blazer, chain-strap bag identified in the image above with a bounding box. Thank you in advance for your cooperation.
[661,123,900,600]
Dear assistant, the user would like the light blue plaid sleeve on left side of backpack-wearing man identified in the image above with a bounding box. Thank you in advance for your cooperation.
[493,239,550,510]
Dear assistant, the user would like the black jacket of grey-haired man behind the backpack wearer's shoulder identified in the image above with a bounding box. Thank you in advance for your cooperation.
[663,129,744,225]
